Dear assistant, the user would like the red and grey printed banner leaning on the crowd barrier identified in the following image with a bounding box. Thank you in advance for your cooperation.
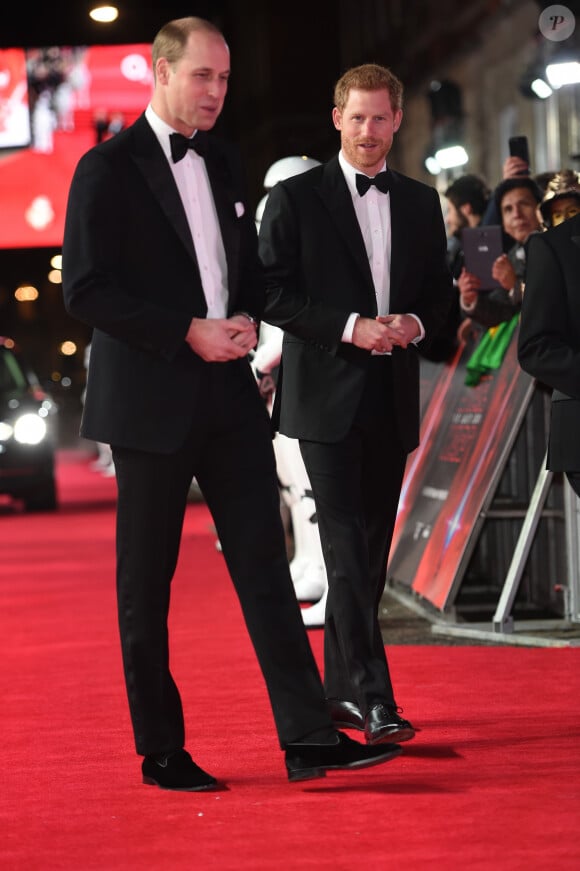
[387,330,534,611]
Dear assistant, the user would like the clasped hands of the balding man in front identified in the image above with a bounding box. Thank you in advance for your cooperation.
[185,315,258,363]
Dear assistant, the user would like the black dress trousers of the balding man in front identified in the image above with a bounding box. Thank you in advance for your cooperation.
[113,361,331,755]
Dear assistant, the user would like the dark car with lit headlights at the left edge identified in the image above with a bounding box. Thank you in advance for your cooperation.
[0,336,57,511]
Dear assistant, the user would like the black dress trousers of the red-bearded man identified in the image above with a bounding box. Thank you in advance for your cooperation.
[300,356,406,713]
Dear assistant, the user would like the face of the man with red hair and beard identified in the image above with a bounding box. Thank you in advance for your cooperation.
[332,88,403,175]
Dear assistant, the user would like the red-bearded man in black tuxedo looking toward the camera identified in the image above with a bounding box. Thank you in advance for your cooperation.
[260,64,453,746]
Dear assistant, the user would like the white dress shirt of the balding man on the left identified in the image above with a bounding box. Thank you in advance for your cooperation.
[145,105,228,318]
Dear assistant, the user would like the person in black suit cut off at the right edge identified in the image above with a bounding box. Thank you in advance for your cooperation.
[518,215,580,496]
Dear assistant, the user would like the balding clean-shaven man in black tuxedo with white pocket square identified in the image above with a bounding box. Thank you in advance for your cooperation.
[63,18,400,791]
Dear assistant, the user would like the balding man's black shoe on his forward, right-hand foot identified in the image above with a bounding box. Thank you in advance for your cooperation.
[286,732,402,782]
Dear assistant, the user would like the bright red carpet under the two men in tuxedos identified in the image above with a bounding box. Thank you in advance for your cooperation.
[0,454,580,871]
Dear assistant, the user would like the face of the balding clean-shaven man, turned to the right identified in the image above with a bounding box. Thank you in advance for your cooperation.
[153,31,230,137]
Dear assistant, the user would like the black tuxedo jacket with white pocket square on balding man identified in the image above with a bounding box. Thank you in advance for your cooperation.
[63,115,264,452]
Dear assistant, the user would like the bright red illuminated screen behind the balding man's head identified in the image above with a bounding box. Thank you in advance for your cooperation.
[0,43,152,248]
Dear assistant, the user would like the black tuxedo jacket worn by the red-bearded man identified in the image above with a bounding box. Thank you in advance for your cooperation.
[260,156,454,451]
